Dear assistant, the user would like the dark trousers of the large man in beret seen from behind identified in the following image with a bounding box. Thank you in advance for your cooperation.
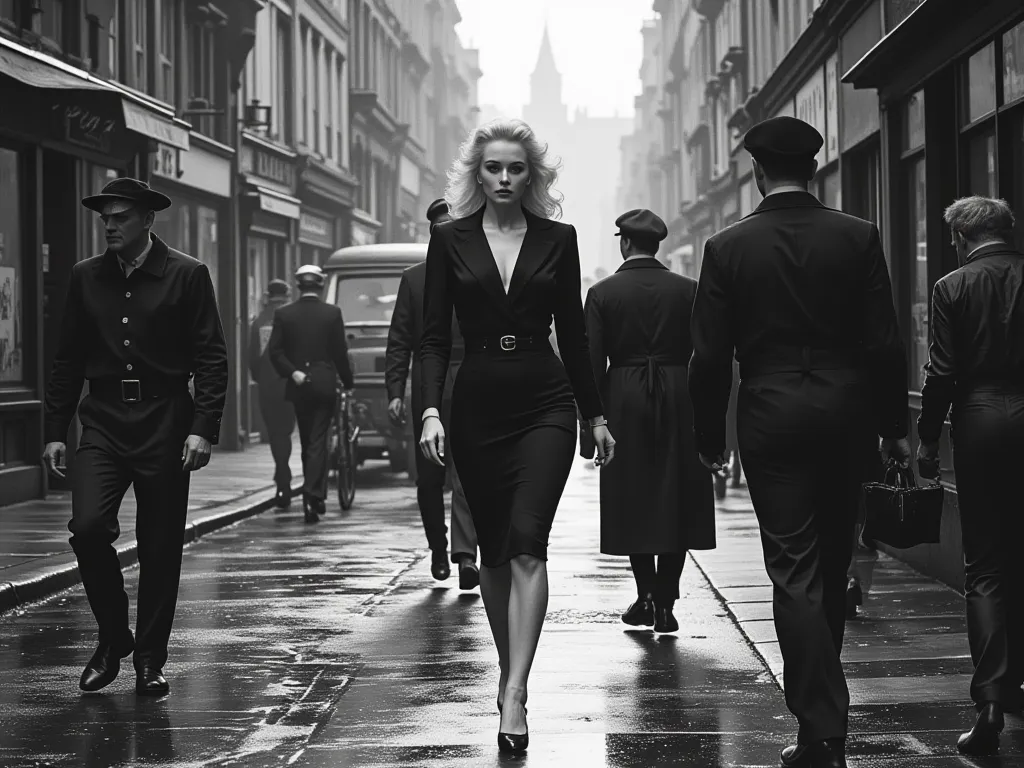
[737,371,879,743]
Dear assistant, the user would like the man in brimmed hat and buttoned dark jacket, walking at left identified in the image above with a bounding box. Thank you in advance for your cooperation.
[43,178,227,695]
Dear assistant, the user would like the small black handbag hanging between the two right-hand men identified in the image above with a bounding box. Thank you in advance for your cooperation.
[863,460,942,549]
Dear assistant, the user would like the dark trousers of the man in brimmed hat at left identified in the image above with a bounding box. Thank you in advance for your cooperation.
[68,391,193,669]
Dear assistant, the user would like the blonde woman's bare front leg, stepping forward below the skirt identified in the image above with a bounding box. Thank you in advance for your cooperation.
[497,555,548,734]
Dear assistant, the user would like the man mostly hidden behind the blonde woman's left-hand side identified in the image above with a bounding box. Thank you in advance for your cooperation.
[384,198,480,590]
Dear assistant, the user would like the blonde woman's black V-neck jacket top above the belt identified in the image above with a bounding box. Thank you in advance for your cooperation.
[417,208,602,419]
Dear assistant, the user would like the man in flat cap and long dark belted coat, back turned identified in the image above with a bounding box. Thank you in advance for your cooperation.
[584,209,715,632]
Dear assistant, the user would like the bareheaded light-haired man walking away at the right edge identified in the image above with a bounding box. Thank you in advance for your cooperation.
[918,197,1024,756]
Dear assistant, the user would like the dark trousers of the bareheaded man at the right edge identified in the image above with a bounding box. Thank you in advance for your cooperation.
[952,386,1024,709]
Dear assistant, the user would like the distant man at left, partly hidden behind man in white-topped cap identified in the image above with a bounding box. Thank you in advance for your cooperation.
[249,280,295,509]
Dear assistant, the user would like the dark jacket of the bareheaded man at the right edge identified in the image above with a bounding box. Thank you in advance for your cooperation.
[918,243,1024,442]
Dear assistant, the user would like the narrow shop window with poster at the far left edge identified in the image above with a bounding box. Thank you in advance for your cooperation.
[0,148,24,384]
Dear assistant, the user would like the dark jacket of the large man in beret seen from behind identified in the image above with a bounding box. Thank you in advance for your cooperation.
[689,191,908,456]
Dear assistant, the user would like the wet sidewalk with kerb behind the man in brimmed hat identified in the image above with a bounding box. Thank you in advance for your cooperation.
[0,437,302,613]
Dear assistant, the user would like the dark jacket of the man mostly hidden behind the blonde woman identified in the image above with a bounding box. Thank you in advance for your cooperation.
[384,261,464,411]
